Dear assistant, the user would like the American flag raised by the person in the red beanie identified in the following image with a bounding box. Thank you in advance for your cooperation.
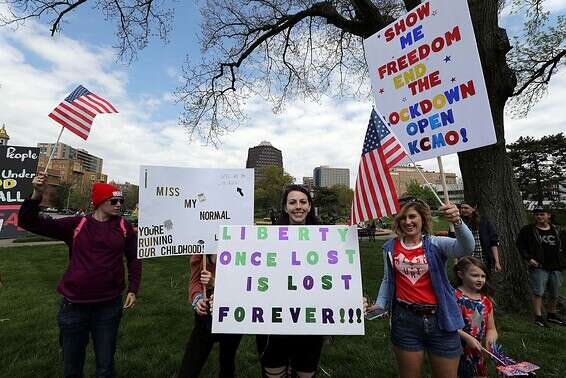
[49,85,118,140]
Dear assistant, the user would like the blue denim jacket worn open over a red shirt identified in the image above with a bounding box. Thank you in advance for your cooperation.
[375,223,475,332]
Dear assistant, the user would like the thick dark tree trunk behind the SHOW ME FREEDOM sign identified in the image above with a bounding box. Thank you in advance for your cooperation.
[458,0,530,310]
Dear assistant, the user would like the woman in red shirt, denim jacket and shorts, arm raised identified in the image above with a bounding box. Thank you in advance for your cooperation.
[368,200,475,378]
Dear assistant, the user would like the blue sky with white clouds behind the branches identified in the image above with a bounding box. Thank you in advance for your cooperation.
[0,0,566,185]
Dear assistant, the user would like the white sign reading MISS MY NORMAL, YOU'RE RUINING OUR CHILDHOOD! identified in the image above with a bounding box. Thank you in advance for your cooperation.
[138,166,254,258]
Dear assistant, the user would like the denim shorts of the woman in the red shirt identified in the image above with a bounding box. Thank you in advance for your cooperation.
[391,302,462,358]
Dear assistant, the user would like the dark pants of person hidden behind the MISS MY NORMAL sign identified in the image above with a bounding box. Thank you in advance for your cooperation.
[179,313,242,378]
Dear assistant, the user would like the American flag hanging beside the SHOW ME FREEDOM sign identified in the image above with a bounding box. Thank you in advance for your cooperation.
[350,109,406,224]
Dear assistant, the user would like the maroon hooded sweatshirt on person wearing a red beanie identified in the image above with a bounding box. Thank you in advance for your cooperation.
[18,199,142,303]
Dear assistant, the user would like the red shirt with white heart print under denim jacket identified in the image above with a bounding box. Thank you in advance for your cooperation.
[393,239,436,304]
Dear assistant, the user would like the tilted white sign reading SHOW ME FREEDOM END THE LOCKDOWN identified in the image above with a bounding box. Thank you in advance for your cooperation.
[364,0,496,160]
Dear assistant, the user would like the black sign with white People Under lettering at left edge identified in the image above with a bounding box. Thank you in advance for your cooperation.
[0,146,39,239]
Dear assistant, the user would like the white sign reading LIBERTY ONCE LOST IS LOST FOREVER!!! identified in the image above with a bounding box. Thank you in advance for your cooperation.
[212,226,364,335]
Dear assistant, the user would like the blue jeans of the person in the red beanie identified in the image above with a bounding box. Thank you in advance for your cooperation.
[57,296,122,378]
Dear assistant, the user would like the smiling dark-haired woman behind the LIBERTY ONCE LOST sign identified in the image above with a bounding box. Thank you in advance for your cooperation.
[256,185,322,378]
